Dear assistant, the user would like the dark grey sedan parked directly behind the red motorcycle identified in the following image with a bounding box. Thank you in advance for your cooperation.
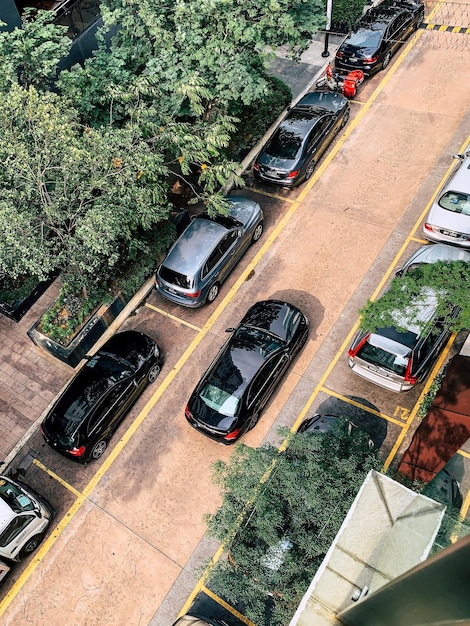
[253,91,349,187]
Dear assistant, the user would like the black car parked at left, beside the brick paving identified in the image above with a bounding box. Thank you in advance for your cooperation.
[41,330,163,463]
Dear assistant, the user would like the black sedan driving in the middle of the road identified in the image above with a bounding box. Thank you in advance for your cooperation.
[185,300,308,444]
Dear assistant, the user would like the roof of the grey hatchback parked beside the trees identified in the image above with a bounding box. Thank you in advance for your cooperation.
[162,217,228,276]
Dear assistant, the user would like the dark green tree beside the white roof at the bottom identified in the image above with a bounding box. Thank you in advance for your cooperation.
[206,421,380,626]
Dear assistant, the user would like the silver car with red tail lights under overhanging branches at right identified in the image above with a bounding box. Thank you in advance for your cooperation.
[348,288,459,392]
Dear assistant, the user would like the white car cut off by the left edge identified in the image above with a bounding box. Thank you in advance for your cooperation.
[0,476,56,560]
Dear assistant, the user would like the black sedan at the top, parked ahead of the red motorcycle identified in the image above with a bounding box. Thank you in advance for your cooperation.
[335,0,424,75]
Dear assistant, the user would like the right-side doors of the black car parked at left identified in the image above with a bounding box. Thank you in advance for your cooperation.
[86,378,139,445]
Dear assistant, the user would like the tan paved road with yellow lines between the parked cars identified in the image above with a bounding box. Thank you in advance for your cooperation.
[0,17,470,626]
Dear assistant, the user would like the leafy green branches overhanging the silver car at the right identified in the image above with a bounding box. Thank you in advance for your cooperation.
[360,261,470,332]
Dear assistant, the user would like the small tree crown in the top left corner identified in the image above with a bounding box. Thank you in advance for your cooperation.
[0,8,71,92]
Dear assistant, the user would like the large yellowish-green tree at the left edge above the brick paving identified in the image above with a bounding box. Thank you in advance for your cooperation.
[0,85,169,295]
